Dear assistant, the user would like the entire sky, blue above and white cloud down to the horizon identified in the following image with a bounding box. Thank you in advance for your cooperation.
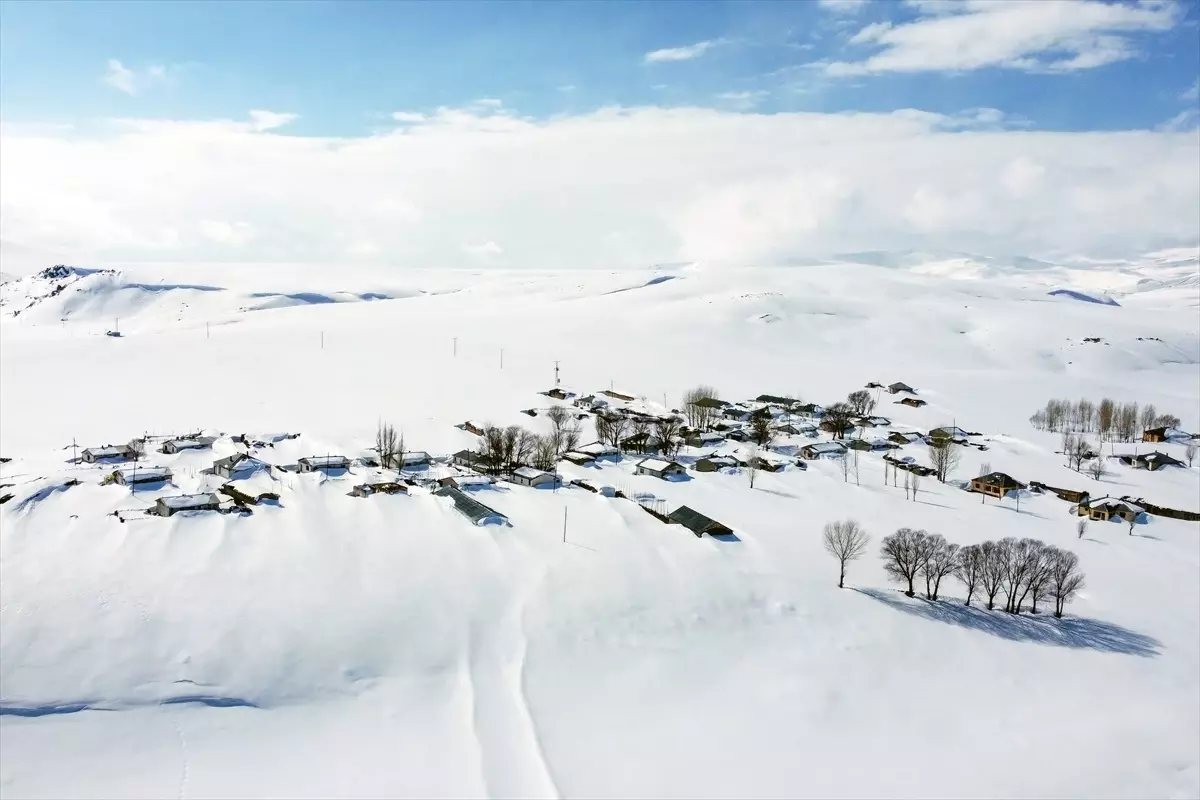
[0,0,1200,266]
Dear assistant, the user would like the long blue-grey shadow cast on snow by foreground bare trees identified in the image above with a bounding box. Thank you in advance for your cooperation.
[856,589,1162,657]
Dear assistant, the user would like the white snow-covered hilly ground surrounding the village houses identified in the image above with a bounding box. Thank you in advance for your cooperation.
[0,257,1200,798]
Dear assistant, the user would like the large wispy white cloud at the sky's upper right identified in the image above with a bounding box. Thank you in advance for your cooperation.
[826,0,1181,76]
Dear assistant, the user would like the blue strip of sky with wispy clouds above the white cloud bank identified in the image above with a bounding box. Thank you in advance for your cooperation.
[0,0,1200,136]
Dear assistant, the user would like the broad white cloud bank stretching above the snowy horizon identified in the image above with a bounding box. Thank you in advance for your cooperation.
[0,108,1200,267]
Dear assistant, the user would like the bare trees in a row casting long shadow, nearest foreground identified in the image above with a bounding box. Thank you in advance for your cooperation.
[824,519,1085,616]
